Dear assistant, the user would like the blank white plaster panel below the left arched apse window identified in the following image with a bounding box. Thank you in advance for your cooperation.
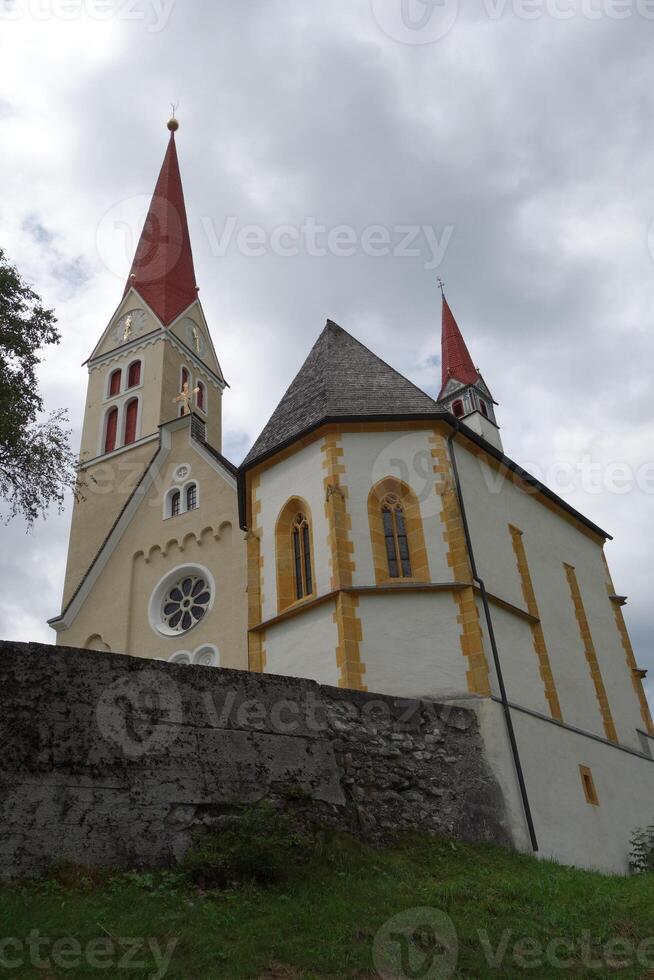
[264,600,338,687]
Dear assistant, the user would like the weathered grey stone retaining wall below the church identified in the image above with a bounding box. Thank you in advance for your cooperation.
[0,643,510,876]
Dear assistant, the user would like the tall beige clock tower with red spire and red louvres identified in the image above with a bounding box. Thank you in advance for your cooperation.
[64,119,226,603]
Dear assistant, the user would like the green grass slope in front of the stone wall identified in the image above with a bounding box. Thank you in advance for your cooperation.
[0,835,654,980]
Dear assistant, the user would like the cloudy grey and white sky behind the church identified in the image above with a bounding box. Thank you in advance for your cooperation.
[0,0,654,712]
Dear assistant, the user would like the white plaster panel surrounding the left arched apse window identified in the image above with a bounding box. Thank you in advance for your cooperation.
[257,439,331,620]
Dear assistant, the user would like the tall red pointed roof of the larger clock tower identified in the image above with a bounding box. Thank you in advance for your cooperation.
[125,120,197,326]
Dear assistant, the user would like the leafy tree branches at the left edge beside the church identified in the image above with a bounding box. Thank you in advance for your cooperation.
[0,249,76,528]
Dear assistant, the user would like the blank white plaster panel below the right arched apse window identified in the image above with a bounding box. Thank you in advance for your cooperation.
[359,592,468,697]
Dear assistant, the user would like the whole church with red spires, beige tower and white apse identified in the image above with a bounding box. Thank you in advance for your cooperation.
[50,119,654,872]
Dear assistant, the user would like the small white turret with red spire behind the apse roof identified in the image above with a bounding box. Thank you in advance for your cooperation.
[437,293,503,451]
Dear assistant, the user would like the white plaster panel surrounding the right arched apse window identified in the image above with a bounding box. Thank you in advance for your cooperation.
[341,429,452,585]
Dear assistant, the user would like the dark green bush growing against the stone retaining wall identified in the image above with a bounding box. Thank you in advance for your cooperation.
[183,803,312,888]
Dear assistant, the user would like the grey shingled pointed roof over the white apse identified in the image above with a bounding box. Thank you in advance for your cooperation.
[243,320,442,466]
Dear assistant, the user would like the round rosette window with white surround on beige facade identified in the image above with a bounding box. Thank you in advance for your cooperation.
[149,565,215,636]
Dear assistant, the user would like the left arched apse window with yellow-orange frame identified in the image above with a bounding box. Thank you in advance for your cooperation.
[275,497,315,612]
